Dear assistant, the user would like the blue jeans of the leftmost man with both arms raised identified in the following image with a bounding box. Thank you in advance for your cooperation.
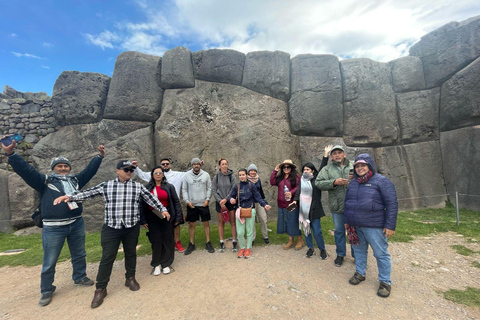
[40,218,87,294]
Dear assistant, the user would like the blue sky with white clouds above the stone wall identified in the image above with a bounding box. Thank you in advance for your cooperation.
[0,0,480,95]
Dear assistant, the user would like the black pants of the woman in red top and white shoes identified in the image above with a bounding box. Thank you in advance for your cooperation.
[147,219,175,268]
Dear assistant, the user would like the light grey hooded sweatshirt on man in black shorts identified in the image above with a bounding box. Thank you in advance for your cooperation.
[182,169,212,207]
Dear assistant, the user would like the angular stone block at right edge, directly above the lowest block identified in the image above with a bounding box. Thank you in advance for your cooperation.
[440,56,480,131]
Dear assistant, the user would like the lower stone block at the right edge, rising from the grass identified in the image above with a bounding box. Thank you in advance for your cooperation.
[440,126,480,211]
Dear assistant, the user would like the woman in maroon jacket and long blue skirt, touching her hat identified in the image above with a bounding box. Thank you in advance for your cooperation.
[270,160,303,250]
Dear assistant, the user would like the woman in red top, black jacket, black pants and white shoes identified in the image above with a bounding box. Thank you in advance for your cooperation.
[140,166,182,276]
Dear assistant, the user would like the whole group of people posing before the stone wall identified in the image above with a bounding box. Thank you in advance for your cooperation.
[2,136,398,308]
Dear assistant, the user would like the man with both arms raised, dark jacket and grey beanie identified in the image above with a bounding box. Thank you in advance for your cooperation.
[2,138,105,307]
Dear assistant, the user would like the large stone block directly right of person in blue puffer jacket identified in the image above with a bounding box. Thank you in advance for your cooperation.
[374,140,447,210]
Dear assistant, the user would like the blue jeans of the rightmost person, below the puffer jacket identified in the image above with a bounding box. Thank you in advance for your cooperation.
[352,227,392,284]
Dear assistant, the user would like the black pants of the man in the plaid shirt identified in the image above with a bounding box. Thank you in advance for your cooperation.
[96,224,140,289]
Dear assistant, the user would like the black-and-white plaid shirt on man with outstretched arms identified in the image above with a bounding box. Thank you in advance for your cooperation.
[69,178,167,229]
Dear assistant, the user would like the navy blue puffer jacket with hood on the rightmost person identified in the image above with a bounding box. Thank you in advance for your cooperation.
[344,153,398,230]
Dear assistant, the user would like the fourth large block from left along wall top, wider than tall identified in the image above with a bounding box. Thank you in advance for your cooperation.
[193,49,245,85]
